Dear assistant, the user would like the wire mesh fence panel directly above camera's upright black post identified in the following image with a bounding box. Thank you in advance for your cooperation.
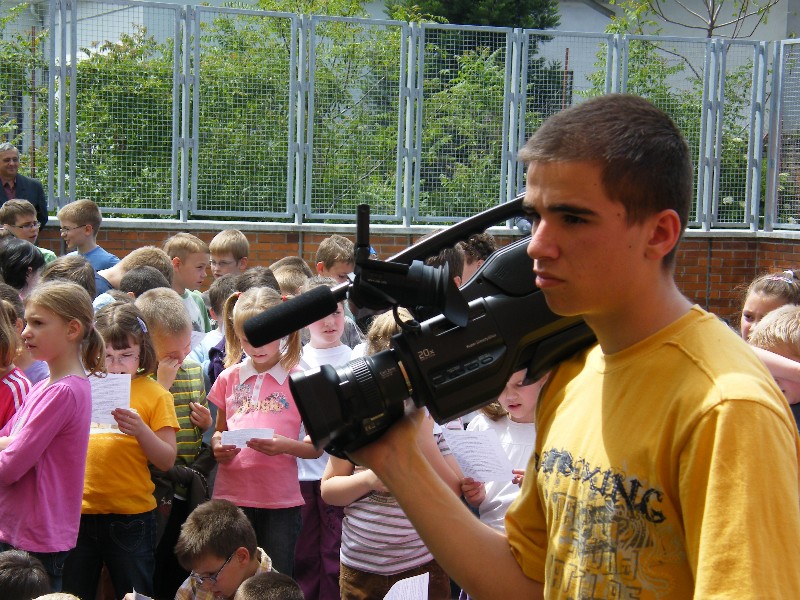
[305,17,408,222]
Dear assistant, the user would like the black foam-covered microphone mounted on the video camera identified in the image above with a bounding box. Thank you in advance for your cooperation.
[244,283,350,347]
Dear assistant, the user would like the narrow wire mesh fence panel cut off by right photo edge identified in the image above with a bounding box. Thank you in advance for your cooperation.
[773,41,800,229]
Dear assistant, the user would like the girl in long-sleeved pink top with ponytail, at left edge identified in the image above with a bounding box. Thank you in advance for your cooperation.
[0,281,105,591]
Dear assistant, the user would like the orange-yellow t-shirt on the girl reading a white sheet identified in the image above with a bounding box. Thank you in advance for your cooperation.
[81,377,178,515]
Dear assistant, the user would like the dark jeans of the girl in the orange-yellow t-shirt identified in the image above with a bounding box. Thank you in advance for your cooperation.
[64,511,156,598]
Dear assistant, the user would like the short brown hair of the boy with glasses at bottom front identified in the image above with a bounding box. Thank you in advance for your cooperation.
[175,500,258,571]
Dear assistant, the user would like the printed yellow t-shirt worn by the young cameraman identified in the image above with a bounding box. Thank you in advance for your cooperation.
[506,307,800,600]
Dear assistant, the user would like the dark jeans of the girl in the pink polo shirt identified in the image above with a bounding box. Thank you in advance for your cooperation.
[241,506,300,576]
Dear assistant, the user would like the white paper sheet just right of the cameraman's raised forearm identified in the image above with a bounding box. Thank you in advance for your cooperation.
[444,429,514,483]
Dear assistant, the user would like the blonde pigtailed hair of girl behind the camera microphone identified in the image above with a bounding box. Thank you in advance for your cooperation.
[224,287,302,371]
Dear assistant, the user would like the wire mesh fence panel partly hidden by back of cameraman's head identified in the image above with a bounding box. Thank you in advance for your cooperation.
[621,36,711,223]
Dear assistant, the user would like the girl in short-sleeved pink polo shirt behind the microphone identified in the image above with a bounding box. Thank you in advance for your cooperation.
[208,288,321,575]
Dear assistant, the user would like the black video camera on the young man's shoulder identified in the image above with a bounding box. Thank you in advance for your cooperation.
[245,196,595,457]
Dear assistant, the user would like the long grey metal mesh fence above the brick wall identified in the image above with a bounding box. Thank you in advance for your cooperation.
[10,0,800,228]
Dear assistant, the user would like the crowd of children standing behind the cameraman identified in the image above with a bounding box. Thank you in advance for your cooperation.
[0,190,800,600]
